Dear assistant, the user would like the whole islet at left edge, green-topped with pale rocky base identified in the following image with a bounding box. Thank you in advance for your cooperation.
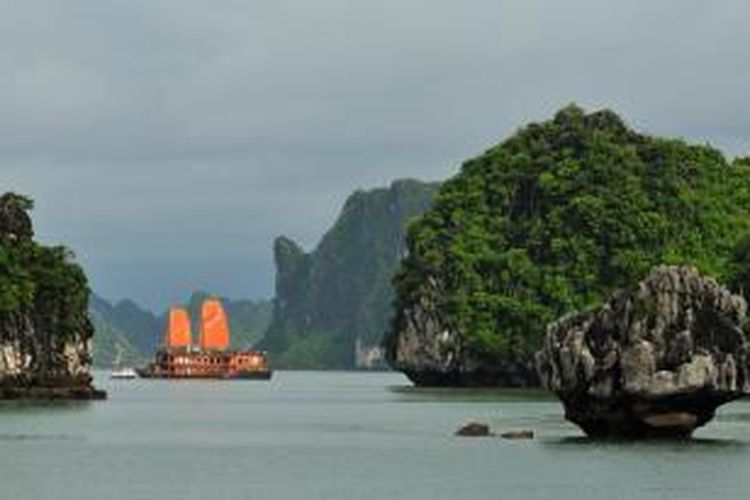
[0,193,104,399]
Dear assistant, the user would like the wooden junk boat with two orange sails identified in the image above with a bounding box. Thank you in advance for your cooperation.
[136,299,272,380]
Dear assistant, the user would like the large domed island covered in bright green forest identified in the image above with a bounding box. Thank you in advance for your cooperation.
[386,106,750,385]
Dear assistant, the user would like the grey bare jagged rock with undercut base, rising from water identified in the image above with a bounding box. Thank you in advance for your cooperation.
[538,267,750,437]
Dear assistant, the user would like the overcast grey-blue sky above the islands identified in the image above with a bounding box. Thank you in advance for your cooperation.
[0,0,750,309]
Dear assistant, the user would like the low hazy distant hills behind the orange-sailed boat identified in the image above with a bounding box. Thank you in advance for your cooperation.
[89,291,271,367]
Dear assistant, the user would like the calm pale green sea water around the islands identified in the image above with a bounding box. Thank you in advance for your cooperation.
[0,372,750,500]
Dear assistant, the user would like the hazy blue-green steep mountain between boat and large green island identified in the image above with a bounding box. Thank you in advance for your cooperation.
[261,180,438,369]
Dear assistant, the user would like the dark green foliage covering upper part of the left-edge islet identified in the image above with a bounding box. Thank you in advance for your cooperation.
[0,193,91,339]
